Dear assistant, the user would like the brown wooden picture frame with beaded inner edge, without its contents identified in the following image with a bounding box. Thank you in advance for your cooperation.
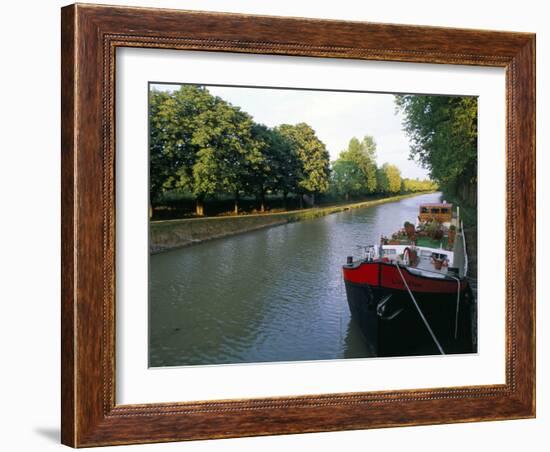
[61,4,535,447]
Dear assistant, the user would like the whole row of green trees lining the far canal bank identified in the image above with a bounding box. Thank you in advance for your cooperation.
[149,85,434,219]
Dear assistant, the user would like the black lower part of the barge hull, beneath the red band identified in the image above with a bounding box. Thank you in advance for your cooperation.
[345,280,477,356]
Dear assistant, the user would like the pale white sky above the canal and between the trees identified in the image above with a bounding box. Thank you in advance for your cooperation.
[152,85,428,179]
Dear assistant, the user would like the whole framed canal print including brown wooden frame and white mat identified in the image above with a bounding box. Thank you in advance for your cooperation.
[62,4,535,447]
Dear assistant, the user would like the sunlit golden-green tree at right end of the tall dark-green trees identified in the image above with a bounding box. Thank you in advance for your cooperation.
[277,122,330,208]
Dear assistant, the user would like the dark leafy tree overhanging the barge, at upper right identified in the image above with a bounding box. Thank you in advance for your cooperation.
[395,95,477,204]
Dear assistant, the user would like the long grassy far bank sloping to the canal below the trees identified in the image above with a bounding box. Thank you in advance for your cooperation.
[149,192,436,253]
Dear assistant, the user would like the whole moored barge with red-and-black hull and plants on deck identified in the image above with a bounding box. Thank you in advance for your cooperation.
[343,202,477,356]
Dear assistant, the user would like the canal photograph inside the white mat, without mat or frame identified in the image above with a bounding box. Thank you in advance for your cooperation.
[149,81,478,368]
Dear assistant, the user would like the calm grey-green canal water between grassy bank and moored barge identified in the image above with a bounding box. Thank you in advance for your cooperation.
[149,193,441,367]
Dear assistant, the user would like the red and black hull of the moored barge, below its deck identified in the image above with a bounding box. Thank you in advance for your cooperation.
[343,262,475,356]
